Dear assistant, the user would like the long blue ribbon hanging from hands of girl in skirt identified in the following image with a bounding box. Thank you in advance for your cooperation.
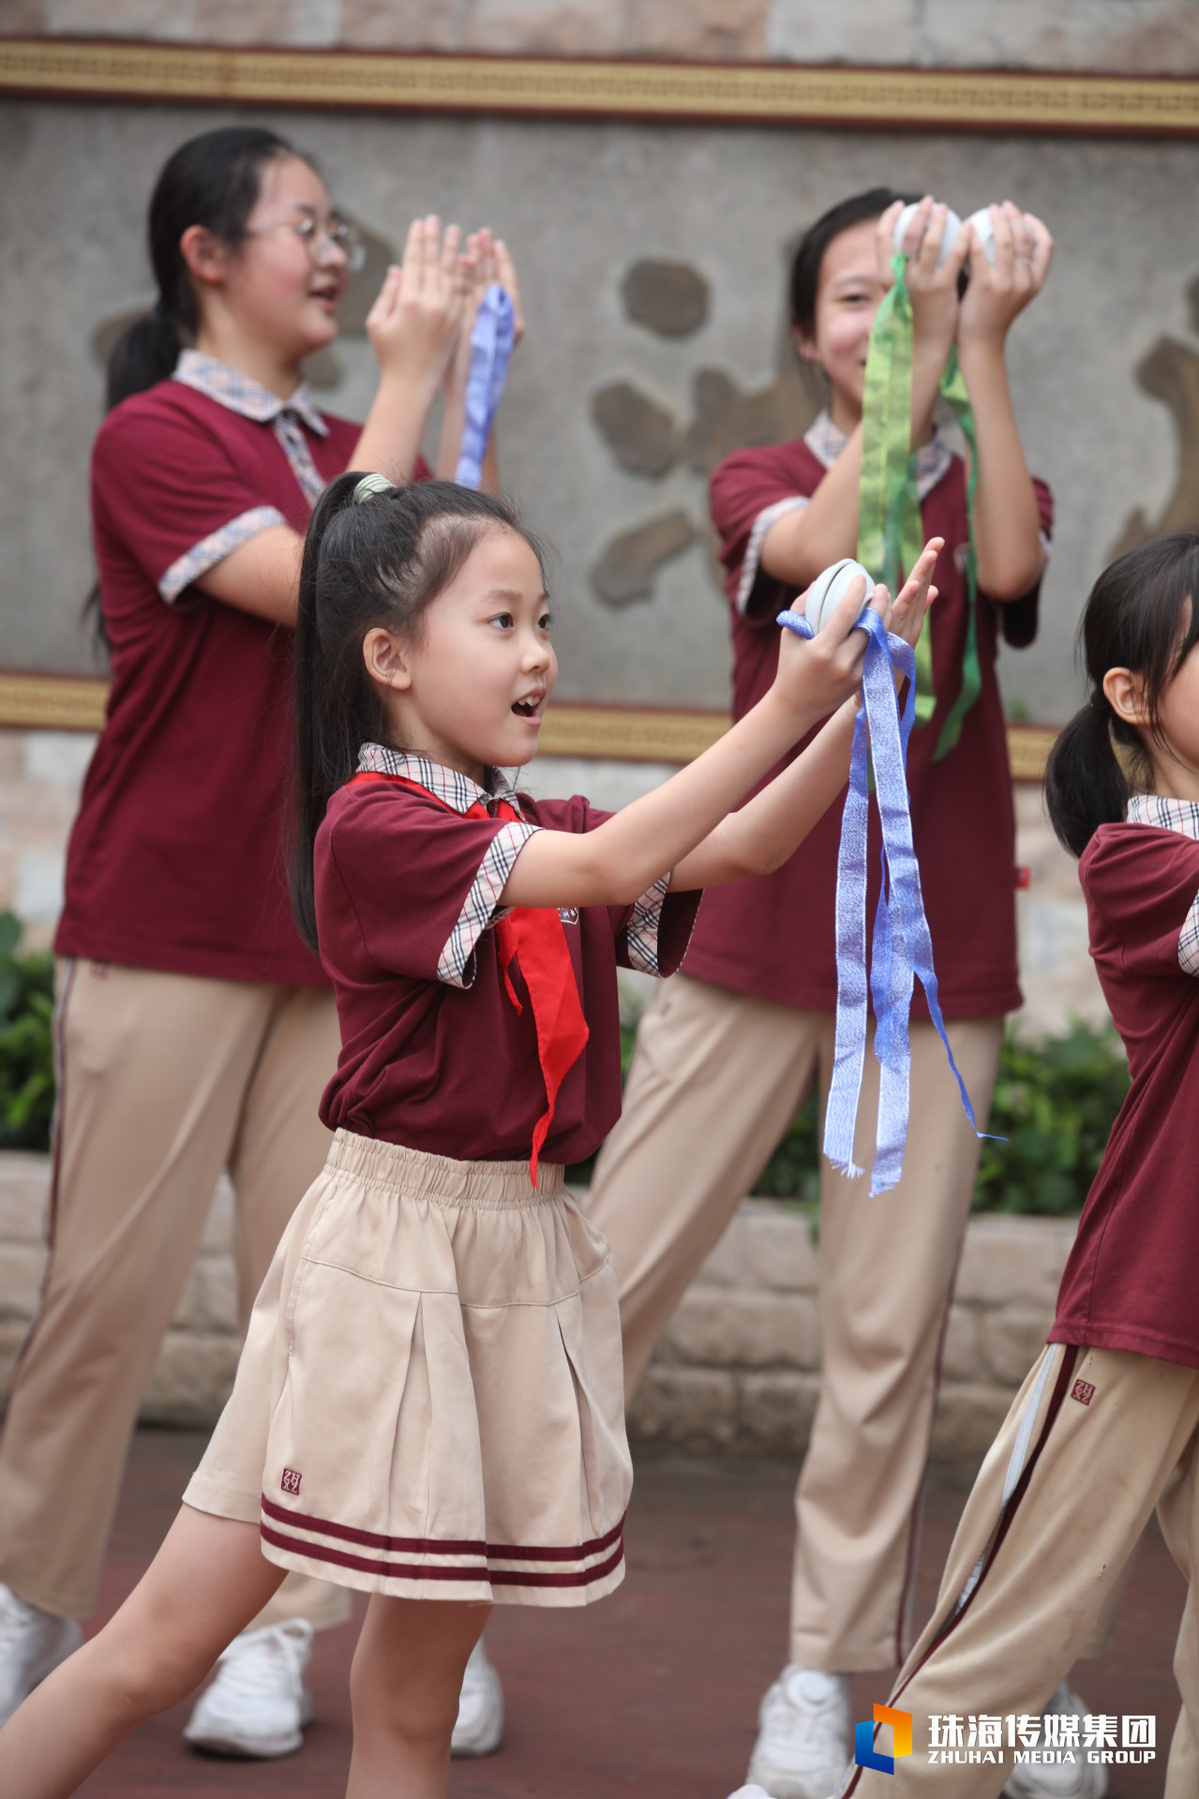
[778,608,983,1195]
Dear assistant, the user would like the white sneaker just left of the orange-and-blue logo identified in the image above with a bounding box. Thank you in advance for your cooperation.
[745,1662,850,1799]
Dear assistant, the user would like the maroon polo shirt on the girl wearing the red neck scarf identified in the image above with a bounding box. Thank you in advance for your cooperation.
[315,761,699,1162]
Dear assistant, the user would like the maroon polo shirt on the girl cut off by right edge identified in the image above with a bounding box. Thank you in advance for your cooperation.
[1050,823,1199,1367]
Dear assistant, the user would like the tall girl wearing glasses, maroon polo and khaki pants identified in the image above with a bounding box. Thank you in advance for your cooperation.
[0,126,513,1756]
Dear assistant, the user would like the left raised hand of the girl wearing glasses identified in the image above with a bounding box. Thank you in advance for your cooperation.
[365,214,473,389]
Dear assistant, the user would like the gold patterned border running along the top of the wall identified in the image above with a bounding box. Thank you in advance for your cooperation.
[0,38,1199,137]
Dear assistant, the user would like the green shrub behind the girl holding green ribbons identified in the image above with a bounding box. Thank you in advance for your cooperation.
[754,1020,1129,1214]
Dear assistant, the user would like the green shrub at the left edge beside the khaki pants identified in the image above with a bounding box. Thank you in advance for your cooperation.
[0,912,54,1150]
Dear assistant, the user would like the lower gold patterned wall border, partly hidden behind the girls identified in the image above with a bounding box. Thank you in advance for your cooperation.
[0,669,1057,781]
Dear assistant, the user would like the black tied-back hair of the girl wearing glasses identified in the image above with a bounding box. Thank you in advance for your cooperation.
[108,124,295,410]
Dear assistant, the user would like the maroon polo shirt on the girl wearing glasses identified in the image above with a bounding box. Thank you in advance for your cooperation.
[54,380,430,986]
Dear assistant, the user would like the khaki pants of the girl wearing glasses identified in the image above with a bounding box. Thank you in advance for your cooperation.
[0,961,346,1624]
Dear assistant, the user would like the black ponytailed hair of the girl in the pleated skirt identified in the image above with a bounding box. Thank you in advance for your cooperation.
[292,470,544,950]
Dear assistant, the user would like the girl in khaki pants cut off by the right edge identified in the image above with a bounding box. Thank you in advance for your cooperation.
[846,533,1199,1799]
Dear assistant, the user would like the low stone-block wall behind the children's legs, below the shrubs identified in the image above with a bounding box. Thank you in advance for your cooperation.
[0,1153,1075,1472]
